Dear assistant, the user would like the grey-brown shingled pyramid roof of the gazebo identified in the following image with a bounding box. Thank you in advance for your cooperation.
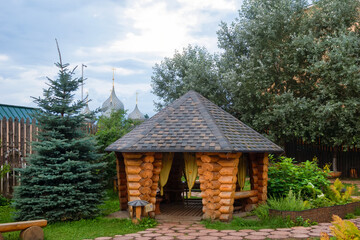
[106,91,283,152]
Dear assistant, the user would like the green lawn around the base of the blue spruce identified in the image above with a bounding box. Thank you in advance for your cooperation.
[0,191,149,240]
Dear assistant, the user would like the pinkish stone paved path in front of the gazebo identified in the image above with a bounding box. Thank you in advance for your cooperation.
[88,218,360,240]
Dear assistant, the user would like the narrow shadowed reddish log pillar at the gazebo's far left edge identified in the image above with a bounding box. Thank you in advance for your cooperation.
[116,153,128,210]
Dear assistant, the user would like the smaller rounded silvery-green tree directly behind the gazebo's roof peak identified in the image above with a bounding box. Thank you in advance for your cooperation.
[151,45,228,109]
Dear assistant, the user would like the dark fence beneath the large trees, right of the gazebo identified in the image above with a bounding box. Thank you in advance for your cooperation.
[285,140,360,177]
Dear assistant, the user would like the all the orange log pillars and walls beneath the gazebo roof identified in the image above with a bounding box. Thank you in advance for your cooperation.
[116,152,269,221]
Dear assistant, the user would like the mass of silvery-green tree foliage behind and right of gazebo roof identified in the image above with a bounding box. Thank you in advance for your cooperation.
[152,0,360,150]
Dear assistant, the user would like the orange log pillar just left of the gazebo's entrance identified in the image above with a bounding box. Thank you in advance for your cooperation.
[123,153,162,215]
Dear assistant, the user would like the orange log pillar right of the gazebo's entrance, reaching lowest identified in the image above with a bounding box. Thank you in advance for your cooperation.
[196,153,241,221]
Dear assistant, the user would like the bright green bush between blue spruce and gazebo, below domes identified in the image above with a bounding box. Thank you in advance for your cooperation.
[96,110,135,186]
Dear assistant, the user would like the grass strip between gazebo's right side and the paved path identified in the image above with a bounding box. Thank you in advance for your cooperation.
[202,217,292,230]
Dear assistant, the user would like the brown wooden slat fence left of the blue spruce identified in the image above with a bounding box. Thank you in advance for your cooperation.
[0,117,38,196]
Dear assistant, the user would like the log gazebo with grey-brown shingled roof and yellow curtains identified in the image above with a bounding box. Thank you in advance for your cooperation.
[106,91,283,221]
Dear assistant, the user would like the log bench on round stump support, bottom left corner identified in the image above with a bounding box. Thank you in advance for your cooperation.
[0,219,47,240]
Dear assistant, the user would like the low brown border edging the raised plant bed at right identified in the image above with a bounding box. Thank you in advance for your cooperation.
[269,202,360,223]
